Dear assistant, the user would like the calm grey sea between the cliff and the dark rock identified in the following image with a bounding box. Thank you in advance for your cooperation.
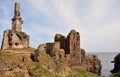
[87,52,120,76]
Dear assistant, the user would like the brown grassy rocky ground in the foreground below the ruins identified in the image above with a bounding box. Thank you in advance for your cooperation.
[0,49,99,77]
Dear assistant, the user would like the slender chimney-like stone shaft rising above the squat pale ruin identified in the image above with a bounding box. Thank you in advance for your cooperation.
[12,3,23,32]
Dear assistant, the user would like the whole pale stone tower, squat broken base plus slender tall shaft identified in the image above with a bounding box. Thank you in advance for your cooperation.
[1,3,29,50]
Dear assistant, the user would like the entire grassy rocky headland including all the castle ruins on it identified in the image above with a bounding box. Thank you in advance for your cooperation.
[0,3,102,77]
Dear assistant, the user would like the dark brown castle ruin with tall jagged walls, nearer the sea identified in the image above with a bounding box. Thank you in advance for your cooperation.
[37,29,84,66]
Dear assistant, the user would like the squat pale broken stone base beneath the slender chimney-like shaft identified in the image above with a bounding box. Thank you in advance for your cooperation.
[1,30,29,50]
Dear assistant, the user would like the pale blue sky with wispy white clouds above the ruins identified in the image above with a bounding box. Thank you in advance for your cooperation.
[0,0,120,52]
